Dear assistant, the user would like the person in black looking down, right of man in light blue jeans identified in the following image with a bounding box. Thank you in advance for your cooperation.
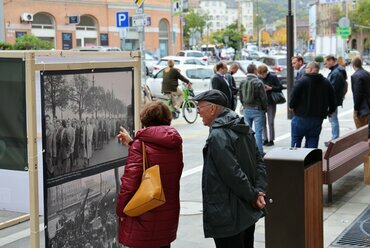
[257,65,283,146]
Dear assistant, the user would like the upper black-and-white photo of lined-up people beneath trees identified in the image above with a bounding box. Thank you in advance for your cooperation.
[42,70,133,178]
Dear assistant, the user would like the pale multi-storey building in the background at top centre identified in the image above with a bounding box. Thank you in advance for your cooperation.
[198,0,253,35]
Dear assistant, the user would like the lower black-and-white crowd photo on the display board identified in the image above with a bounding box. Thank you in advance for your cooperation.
[46,167,123,248]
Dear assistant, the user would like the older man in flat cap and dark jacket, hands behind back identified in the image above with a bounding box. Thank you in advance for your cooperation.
[195,90,267,248]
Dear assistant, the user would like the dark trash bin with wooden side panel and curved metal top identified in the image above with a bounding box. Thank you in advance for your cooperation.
[265,148,323,248]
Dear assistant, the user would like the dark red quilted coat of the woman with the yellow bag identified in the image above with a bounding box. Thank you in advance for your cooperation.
[116,126,183,248]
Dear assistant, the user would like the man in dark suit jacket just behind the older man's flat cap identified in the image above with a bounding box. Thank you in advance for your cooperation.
[211,62,235,109]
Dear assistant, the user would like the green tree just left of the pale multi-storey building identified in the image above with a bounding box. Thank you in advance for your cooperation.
[184,10,208,44]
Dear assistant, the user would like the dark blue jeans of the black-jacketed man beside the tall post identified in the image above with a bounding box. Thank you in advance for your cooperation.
[291,116,323,148]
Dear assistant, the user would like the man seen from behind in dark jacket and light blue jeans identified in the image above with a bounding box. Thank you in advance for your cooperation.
[240,64,267,156]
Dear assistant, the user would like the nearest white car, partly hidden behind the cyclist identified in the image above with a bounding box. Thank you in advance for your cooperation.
[146,65,214,97]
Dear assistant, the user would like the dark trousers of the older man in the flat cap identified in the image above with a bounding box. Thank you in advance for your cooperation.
[214,225,255,248]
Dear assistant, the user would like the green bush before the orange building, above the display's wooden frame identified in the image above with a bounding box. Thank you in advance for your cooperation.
[14,34,53,50]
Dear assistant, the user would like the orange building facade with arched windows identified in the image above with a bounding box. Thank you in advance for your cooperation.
[3,0,182,56]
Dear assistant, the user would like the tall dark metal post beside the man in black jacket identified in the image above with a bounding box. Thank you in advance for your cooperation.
[286,0,294,119]
